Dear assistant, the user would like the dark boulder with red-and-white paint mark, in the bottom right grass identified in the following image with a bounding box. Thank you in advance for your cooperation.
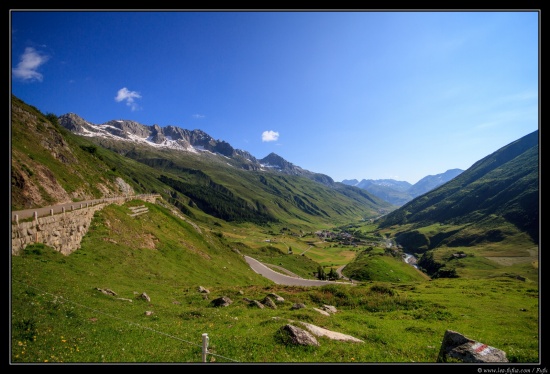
[437,330,508,363]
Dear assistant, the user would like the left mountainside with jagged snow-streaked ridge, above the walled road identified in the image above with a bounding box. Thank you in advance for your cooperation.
[11,97,395,228]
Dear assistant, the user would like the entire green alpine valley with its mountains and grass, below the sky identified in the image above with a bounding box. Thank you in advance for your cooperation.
[10,95,543,370]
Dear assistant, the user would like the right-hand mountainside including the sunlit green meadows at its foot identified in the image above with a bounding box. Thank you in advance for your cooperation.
[370,131,540,280]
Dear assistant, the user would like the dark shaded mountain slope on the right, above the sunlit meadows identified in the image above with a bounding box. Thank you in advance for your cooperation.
[378,131,539,248]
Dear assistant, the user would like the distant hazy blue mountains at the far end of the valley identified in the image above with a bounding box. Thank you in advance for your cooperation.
[342,169,463,206]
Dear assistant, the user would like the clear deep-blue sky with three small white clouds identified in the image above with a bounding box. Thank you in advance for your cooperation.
[10,10,540,184]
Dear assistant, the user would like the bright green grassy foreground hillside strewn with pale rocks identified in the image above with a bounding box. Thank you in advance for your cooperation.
[10,202,540,363]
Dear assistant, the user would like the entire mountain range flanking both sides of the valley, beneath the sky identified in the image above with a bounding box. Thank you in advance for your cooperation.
[11,96,540,274]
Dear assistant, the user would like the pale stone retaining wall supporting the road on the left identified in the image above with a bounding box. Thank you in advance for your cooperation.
[11,195,160,255]
